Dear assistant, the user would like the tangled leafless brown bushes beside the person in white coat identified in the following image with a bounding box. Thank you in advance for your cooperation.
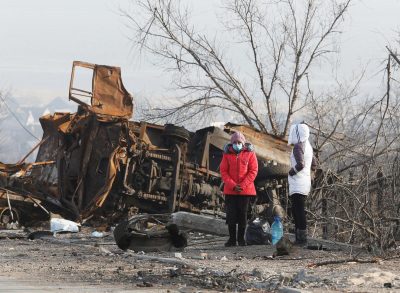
[308,50,400,250]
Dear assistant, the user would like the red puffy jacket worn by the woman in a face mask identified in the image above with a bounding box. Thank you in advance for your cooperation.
[220,143,258,196]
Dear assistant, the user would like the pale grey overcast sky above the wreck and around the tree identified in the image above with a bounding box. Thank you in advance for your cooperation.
[0,0,400,104]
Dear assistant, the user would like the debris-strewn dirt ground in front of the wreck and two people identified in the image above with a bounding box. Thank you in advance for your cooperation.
[0,231,400,292]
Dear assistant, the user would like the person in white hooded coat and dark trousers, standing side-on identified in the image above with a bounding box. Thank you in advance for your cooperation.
[288,123,316,245]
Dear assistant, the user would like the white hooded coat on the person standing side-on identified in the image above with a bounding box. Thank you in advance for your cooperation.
[288,124,313,195]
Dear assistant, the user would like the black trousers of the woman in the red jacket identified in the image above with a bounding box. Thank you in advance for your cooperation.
[225,195,250,227]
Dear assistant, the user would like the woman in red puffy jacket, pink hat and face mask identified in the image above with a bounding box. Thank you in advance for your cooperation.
[220,132,258,247]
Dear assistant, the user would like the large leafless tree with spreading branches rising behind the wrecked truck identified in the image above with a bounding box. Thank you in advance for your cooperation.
[123,0,351,136]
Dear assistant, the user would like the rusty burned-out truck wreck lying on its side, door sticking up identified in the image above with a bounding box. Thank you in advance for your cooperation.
[0,61,290,224]
